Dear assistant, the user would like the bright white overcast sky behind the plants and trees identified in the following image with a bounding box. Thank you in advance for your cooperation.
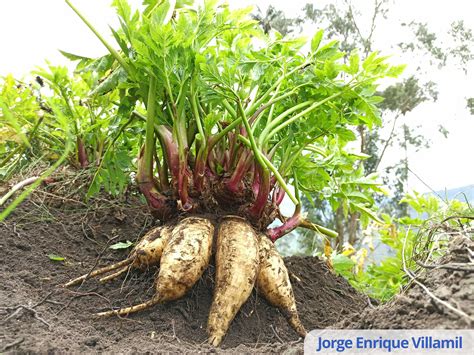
[0,0,474,192]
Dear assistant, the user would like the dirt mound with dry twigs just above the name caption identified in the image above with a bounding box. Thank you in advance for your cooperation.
[337,235,474,329]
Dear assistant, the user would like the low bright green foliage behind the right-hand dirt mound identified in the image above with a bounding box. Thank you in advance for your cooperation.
[331,192,474,302]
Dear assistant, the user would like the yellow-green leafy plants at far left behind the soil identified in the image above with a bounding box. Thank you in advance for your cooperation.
[0,60,142,196]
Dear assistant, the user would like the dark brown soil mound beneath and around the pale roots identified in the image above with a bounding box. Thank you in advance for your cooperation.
[0,200,367,353]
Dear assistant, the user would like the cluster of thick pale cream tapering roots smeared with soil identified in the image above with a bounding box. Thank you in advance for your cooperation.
[65,216,306,346]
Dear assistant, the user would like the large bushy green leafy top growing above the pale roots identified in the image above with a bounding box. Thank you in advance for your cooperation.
[0,0,400,234]
